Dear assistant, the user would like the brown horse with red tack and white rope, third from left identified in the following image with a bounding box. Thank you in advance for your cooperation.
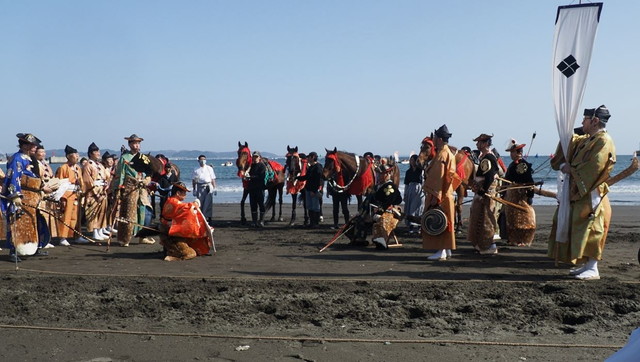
[322,147,375,210]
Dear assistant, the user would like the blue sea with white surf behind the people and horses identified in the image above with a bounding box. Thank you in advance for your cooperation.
[172,155,640,205]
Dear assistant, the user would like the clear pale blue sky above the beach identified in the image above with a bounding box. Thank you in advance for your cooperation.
[0,0,640,155]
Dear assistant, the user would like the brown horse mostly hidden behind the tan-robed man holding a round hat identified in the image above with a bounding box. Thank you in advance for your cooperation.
[418,137,475,234]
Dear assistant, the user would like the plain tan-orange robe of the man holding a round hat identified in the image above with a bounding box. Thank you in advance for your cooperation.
[422,145,460,250]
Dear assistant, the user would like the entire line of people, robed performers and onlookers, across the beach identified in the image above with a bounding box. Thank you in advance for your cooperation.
[0,106,615,280]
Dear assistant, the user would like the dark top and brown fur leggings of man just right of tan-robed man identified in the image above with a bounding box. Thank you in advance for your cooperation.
[467,153,500,250]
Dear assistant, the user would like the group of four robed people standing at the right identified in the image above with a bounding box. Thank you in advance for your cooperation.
[416,106,616,280]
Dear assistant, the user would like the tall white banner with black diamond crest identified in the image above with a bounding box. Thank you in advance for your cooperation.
[552,3,602,242]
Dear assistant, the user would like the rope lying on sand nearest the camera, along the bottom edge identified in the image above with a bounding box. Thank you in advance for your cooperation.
[0,324,623,349]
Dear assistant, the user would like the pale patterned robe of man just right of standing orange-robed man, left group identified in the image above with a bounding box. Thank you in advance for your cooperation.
[82,160,108,231]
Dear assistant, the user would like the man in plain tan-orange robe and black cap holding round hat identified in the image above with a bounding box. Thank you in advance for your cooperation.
[422,125,460,260]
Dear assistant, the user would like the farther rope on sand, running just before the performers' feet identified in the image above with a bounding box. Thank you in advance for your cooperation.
[0,268,640,285]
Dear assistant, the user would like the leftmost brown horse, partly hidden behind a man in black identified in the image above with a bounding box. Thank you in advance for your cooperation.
[236,141,284,225]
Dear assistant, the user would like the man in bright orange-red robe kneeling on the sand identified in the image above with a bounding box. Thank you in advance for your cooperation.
[160,182,210,261]
